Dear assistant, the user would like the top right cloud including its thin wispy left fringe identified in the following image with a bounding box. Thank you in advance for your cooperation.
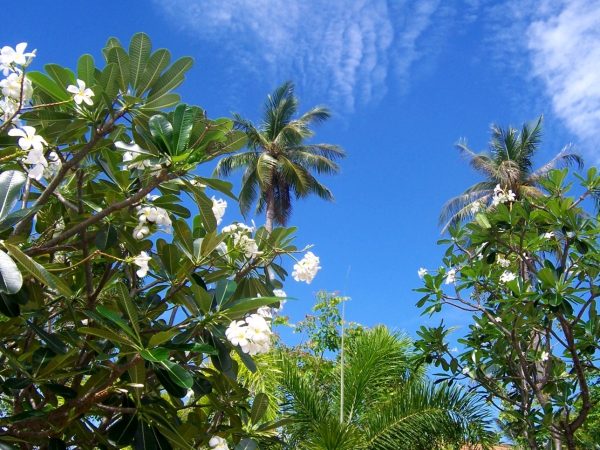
[483,0,600,158]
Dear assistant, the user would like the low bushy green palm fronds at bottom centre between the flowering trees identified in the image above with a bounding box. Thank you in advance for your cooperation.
[282,326,493,450]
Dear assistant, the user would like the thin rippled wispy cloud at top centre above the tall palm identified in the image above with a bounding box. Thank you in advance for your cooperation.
[155,0,440,111]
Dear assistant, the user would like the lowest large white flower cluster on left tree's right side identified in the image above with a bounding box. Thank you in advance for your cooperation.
[225,314,273,356]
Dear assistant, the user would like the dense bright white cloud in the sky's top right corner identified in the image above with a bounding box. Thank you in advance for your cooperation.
[526,0,600,151]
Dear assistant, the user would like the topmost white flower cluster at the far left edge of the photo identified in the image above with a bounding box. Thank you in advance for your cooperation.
[0,42,35,125]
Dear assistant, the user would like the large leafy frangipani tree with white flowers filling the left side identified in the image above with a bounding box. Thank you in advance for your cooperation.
[0,33,304,449]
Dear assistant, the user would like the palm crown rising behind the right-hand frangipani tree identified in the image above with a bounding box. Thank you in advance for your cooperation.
[439,116,583,233]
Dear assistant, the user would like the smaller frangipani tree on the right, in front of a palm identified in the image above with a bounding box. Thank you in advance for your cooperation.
[417,168,600,449]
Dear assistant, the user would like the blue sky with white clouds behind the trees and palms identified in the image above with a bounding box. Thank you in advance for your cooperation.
[1,0,600,342]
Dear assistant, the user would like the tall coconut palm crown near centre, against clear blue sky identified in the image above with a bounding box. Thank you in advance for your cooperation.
[214,82,346,232]
